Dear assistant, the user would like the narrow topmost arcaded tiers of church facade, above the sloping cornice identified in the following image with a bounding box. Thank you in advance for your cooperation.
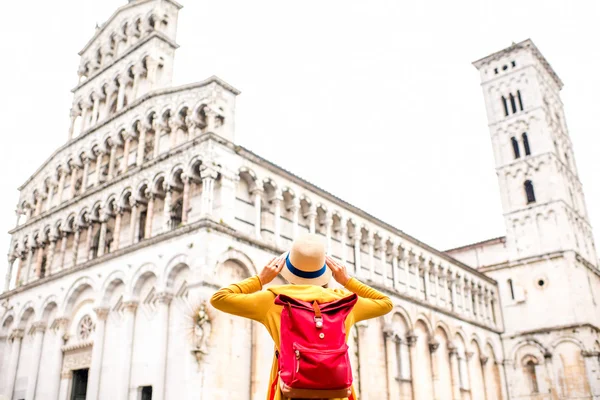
[68,0,182,140]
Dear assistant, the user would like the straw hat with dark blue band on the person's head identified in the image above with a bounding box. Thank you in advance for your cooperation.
[281,234,331,286]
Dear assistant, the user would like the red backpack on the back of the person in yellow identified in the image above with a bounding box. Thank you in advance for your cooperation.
[271,294,358,400]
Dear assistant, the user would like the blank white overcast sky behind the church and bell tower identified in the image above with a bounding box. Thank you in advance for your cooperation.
[0,0,600,276]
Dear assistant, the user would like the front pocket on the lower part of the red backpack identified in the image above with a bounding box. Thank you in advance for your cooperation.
[292,343,352,389]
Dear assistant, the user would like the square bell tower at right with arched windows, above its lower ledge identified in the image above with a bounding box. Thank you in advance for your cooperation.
[473,39,596,265]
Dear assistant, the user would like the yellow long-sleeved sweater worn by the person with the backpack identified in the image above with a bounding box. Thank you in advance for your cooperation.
[210,276,393,400]
